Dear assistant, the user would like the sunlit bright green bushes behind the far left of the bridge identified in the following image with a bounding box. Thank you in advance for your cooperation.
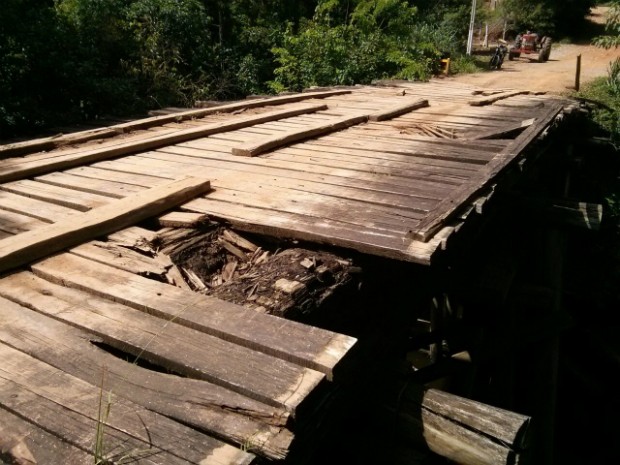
[270,0,440,91]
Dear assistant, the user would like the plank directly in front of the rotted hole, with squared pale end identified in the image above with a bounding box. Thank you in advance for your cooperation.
[33,250,356,378]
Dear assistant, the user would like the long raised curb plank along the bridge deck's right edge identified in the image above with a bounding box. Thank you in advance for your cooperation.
[413,103,562,241]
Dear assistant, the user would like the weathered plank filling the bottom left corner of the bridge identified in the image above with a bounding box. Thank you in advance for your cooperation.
[0,408,93,465]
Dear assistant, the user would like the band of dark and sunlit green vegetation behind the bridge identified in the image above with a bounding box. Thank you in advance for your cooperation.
[0,0,593,140]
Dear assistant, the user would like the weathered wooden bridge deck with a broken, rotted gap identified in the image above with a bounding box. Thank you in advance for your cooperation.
[0,81,566,464]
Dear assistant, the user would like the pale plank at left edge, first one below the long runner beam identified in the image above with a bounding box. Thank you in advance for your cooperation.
[0,179,112,212]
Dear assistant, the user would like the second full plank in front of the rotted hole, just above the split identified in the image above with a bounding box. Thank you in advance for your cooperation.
[0,268,324,416]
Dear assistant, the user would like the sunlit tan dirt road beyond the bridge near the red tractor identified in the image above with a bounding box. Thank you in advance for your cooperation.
[450,7,620,94]
